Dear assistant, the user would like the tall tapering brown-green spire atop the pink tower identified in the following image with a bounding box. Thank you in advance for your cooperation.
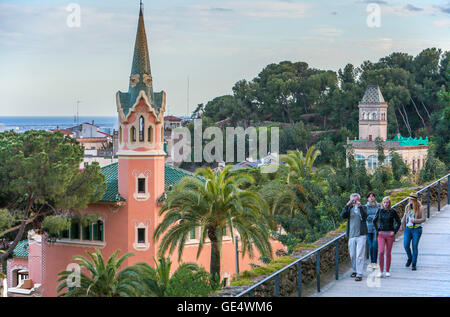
[129,0,153,102]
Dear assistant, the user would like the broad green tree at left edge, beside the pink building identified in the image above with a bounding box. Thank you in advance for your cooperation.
[0,130,104,263]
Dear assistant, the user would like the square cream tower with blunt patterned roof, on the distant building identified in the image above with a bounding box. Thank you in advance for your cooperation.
[358,85,388,141]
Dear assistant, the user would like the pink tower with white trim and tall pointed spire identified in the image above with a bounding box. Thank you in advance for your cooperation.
[116,2,166,263]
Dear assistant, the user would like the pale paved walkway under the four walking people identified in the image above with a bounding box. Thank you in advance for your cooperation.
[313,202,450,297]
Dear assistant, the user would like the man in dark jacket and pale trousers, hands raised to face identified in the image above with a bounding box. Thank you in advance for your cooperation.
[341,193,367,281]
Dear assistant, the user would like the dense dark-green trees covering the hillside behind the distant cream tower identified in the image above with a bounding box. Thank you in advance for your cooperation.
[200,48,450,166]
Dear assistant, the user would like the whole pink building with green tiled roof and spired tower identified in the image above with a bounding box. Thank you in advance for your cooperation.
[7,3,284,296]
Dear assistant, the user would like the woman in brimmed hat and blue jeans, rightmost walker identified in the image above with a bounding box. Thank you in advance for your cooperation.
[401,193,426,271]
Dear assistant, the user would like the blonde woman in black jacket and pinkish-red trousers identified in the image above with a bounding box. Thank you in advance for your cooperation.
[373,196,401,277]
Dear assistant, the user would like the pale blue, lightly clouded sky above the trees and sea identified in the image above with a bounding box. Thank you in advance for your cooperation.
[0,0,450,116]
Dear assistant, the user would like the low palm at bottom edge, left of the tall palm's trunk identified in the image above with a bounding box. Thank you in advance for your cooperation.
[136,257,211,297]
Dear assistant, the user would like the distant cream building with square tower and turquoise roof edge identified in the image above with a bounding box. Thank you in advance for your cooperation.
[347,85,428,172]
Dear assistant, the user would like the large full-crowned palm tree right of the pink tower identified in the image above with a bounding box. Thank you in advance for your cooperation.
[154,166,272,279]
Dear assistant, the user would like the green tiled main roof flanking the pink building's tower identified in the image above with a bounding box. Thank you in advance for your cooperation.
[101,163,194,202]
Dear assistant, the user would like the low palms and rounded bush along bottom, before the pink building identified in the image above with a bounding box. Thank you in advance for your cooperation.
[57,249,214,297]
